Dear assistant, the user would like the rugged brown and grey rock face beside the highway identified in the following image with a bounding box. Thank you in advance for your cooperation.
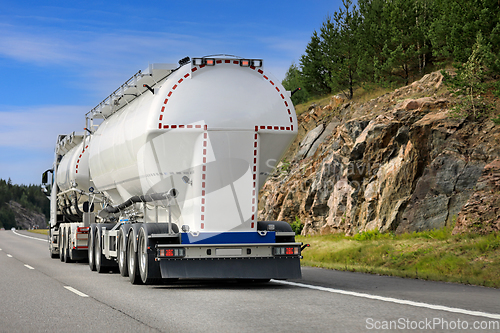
[259,73,500,234]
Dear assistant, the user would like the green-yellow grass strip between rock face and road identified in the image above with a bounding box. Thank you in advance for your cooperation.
[296,228,500,288]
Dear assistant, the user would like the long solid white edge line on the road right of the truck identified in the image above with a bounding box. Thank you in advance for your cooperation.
[272,280,500,319]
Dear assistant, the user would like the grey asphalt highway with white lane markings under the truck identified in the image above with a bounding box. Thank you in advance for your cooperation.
[0,230,500,333]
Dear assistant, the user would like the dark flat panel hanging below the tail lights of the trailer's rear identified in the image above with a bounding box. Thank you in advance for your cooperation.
[160,257,302,279]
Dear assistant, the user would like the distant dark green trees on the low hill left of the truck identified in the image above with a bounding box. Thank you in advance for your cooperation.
[0,178,50,229]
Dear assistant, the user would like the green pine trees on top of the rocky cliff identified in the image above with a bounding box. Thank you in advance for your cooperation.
[283,0,500,104]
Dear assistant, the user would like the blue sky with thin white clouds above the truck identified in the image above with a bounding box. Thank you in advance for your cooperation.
[0,0,340,184]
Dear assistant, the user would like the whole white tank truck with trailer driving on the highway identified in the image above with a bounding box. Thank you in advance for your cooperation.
[42,56,306,284]
